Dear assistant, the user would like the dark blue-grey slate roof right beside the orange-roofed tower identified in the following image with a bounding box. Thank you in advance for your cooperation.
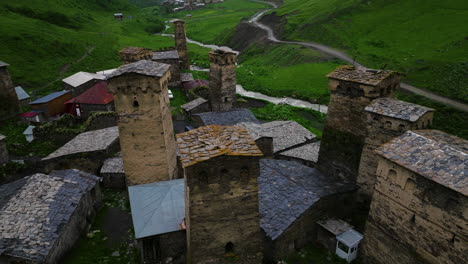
[258,159,356,240]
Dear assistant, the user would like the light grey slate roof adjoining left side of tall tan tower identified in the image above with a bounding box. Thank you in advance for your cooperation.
[43,126,119,160]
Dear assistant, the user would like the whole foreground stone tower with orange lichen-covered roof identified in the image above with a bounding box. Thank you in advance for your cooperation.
[177,125,263,264]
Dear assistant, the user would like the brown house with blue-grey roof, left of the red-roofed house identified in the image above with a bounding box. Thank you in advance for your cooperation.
[29,91,72,118]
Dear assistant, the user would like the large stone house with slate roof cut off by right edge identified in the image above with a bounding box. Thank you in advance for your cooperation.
[363,130,468,264]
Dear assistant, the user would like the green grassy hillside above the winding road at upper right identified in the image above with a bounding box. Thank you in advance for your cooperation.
[272,0,468,102]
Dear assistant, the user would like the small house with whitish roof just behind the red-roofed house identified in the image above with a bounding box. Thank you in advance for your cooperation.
[62,72,106,97]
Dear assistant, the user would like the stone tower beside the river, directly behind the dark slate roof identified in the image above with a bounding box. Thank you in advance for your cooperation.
[209,49,237,112]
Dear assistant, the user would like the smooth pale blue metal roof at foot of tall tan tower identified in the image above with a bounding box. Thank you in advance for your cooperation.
[128,179,185,239]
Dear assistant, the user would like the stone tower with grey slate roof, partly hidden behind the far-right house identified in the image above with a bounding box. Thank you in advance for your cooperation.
[357,98,434,206]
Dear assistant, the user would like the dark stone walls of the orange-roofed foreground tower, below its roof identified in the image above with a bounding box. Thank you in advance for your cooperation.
[185,156,263,264]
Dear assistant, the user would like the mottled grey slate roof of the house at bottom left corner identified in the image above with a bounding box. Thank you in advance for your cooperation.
[0,170,99,263]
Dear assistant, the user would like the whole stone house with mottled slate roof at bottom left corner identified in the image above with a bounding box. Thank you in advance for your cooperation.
[0,170,101,264]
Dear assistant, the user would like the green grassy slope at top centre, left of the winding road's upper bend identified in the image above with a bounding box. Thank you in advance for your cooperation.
[171,0,268,45]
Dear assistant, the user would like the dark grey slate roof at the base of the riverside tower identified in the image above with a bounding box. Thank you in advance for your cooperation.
[194,108,260,126]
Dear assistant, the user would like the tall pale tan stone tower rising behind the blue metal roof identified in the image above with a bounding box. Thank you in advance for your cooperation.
[108,60,177,185]
